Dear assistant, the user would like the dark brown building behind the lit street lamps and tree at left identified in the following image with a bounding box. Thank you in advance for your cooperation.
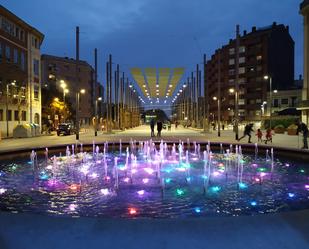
[41,54,95,126]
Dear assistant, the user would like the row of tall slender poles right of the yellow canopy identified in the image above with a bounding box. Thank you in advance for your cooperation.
[172,25,240,140]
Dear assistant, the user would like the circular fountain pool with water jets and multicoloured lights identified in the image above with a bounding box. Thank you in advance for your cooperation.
[0,140,309,218]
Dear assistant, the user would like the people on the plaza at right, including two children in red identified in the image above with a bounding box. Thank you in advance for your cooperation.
[238,122,308,149]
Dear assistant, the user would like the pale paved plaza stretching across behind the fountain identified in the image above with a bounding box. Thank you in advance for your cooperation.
[0,125,309,152]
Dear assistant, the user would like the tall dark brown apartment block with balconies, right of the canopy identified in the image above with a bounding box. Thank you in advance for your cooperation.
[206,23,294,122]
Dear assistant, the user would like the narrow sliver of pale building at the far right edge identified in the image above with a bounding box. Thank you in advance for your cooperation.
[299,0,309,125]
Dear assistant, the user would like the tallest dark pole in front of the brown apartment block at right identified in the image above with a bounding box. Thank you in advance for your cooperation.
[234,25,239,140]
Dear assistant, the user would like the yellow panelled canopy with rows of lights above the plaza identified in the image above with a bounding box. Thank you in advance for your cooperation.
[130,67,185,101]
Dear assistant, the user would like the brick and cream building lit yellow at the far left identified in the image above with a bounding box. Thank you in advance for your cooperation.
[0,5,44,137]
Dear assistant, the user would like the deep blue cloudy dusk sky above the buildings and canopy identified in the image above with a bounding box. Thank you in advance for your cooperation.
[1,0,303,86]
